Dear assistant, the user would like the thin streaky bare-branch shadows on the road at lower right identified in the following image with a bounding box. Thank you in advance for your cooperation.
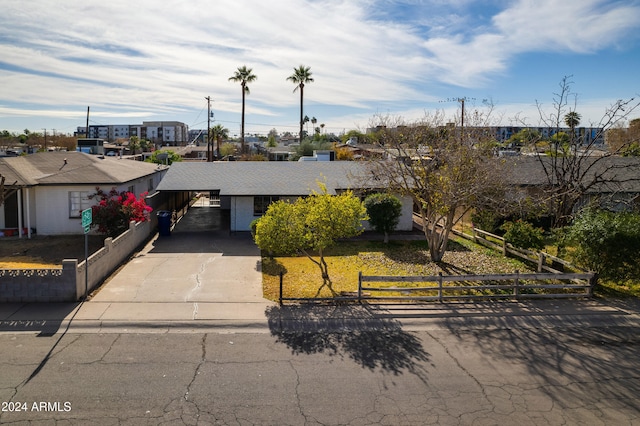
[445,314,640,416]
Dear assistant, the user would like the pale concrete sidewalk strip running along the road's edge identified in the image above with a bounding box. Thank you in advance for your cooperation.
[0,300,640,335]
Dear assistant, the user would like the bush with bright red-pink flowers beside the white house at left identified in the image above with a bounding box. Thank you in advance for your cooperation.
[89,188,153,237]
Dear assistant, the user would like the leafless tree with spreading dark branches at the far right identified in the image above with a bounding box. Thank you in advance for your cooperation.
[524,76,640,227]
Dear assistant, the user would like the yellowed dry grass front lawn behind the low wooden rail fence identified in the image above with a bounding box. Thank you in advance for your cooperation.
[262,240,532,300]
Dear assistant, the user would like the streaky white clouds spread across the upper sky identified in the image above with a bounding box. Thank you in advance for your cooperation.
[0,0,640,133]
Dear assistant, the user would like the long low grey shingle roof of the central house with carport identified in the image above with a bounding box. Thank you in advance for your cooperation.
[158,161,381,196]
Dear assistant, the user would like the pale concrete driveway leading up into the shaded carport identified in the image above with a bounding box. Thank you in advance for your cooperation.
[91,206,268,303]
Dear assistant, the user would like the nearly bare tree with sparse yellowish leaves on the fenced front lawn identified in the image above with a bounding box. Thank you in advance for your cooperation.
[373,110,504,262]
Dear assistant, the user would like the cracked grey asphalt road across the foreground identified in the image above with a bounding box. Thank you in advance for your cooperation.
[0,322,640,426]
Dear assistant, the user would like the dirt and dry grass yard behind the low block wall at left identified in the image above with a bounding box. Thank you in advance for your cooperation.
[0,235,105,268]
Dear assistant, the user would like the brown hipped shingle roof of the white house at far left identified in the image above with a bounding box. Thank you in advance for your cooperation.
[0,151,163,186]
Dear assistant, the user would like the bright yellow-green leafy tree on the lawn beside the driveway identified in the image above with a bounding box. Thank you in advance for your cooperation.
[255,184,367,296]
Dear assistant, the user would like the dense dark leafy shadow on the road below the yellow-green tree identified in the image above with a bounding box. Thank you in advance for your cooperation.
[266,305,430,382]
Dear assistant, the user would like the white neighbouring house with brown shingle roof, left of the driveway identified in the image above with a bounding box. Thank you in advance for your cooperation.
[0,152,167,236]
